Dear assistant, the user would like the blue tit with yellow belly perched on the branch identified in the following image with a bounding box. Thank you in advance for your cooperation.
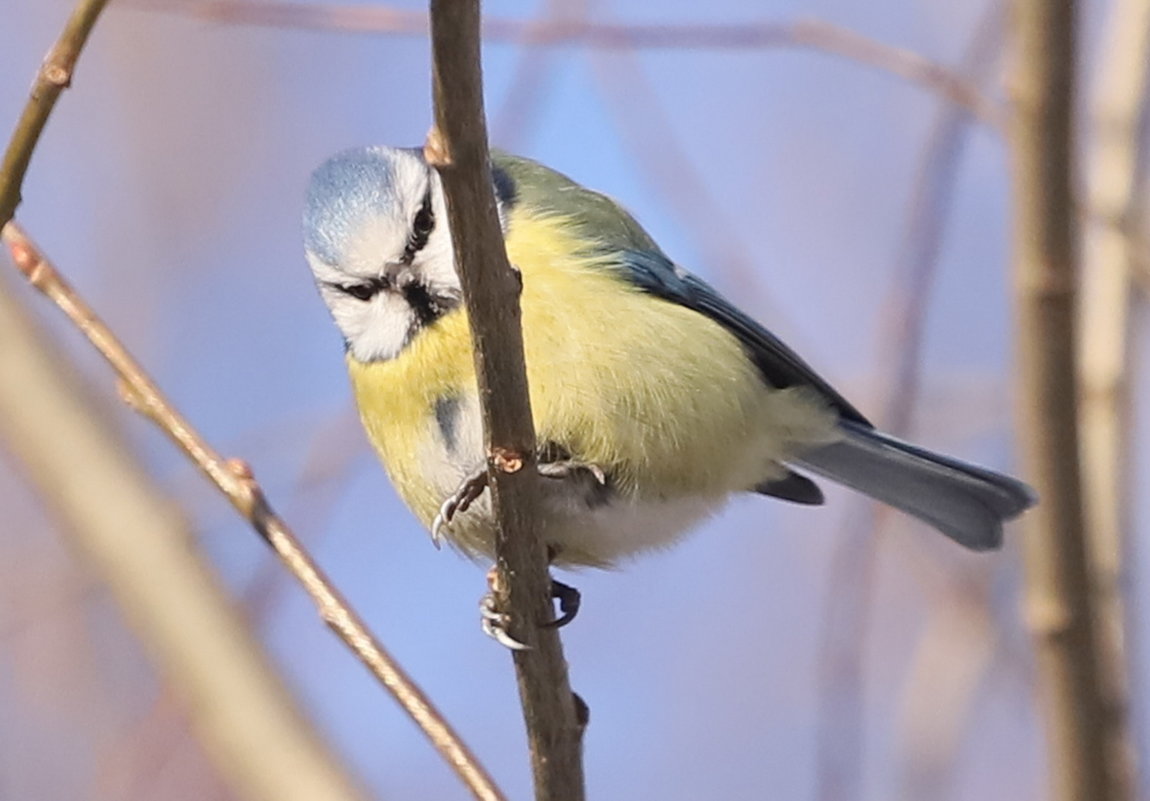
[304,147,1035,567]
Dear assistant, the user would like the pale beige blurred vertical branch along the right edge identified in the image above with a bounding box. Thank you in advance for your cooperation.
[1078,0,1150,800]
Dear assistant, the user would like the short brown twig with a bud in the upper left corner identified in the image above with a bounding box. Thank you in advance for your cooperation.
[0,0,108,229]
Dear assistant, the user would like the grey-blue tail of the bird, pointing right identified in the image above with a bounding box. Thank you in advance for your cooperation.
[795,421,1037,550]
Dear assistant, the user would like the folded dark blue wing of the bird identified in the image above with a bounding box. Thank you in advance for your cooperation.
[622,251,873,428]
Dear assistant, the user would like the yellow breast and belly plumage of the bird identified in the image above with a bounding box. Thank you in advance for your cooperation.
[348,209,835,564]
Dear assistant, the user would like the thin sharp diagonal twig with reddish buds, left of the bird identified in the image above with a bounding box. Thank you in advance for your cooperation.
[2,222,503,801]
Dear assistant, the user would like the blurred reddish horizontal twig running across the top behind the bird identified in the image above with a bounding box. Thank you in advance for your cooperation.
[132,0,1002,129]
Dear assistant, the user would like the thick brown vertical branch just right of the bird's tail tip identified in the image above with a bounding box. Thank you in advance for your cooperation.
[1011,0,1112,801]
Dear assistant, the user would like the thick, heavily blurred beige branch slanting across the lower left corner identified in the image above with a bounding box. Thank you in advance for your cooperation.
[0,268,367,801]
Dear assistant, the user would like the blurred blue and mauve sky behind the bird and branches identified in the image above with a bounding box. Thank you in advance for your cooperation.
[0,0,1148,801]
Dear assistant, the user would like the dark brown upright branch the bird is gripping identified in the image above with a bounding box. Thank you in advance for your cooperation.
[426,0,585,801]
